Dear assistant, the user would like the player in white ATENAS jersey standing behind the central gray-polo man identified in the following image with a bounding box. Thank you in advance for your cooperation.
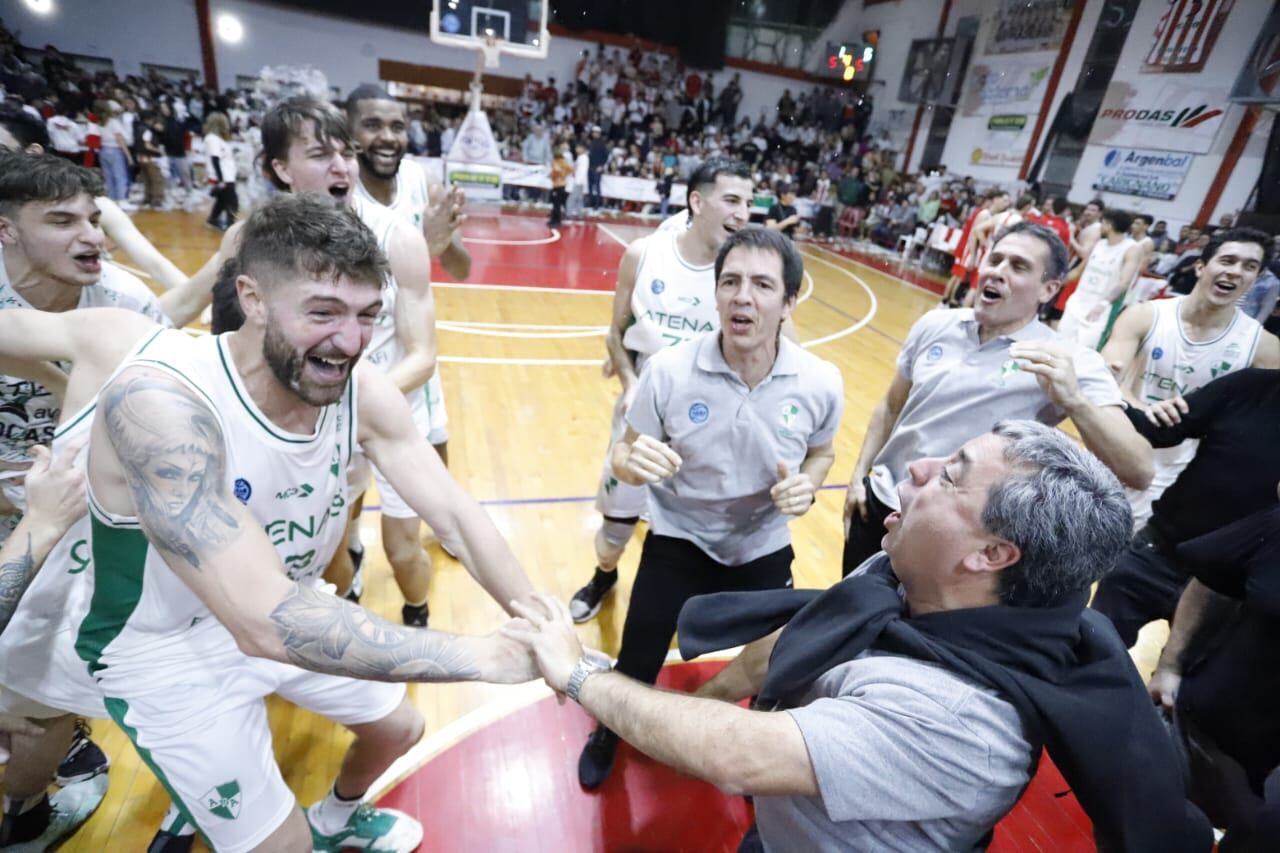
[570,158,751,622]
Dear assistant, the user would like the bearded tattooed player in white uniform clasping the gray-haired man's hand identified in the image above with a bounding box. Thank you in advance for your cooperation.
[4,195,531,852]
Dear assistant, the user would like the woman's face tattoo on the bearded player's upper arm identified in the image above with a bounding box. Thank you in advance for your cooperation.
[102,375,239,570]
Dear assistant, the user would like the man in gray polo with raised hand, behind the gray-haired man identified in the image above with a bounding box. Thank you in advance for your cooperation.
[844,222,1152,575]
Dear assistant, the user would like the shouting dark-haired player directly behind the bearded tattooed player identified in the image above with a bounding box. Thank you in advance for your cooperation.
[177,96,435,626]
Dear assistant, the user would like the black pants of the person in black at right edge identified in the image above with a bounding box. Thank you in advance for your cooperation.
[1089,526,1190,648]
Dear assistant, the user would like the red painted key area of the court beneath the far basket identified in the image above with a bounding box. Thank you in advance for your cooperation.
[445,214,625,291]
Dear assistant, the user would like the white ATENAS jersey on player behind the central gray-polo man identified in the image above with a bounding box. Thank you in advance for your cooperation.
[622,231,719,358]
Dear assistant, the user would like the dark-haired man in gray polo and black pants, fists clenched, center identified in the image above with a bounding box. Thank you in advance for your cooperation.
[579,228,844,788]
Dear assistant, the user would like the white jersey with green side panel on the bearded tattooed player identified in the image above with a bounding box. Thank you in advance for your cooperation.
[76,330,356,695]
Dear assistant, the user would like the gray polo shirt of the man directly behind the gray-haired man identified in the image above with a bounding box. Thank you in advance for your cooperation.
[870,309,1123,508]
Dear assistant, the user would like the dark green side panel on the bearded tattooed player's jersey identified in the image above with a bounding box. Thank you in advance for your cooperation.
[76,506,151,674]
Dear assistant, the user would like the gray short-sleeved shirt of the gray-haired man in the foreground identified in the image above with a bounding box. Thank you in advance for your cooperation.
[755,652,1034,853]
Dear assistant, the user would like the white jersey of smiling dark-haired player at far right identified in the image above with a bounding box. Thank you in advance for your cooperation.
[1126,296,1262,526]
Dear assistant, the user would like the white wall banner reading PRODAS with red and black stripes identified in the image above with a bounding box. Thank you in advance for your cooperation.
[1089,77,1226,154]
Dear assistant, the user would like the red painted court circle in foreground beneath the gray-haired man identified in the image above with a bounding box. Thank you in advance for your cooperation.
[379,662,1094,853]
